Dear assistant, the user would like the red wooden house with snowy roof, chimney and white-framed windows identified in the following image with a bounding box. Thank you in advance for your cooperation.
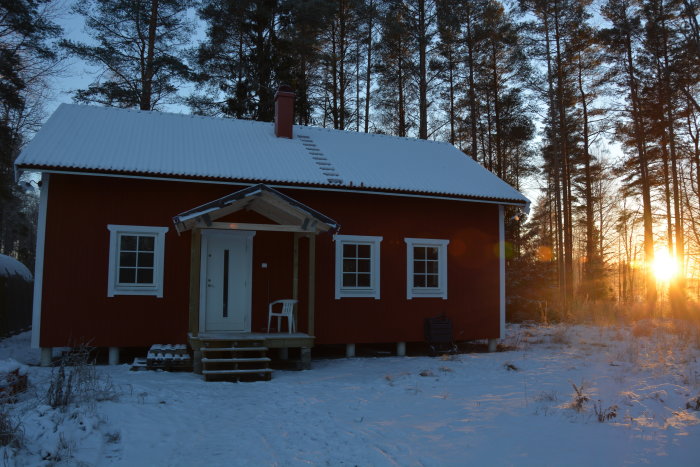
[16,90,529,376]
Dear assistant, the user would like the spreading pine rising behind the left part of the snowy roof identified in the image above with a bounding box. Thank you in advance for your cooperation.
[62,0,193,110]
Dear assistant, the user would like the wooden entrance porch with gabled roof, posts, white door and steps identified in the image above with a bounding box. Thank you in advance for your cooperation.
[173,185,339,380]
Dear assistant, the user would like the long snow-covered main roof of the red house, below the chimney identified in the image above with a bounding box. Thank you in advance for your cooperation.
[16,104,528,204]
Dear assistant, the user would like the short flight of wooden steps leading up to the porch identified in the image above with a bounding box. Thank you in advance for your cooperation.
[201,338,272,381]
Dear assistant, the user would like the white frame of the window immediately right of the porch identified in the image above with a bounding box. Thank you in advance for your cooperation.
[333,235,383,300]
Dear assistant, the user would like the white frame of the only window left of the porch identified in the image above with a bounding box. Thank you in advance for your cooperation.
[107,224,168,298]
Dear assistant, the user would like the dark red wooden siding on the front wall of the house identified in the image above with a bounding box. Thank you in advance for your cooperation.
[40,174,499,347]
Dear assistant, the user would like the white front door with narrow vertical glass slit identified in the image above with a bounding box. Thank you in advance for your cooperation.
[200,230,255,332]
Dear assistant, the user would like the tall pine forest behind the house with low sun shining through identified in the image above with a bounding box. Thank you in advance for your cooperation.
[0,0,700,319]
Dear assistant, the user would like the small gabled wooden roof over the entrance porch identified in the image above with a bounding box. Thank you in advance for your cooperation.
[173,184,340,234]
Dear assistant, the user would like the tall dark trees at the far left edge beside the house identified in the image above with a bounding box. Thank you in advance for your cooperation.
[0,0,61,267]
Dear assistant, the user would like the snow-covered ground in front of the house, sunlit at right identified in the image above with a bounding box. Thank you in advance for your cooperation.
[0,322,700,466]
